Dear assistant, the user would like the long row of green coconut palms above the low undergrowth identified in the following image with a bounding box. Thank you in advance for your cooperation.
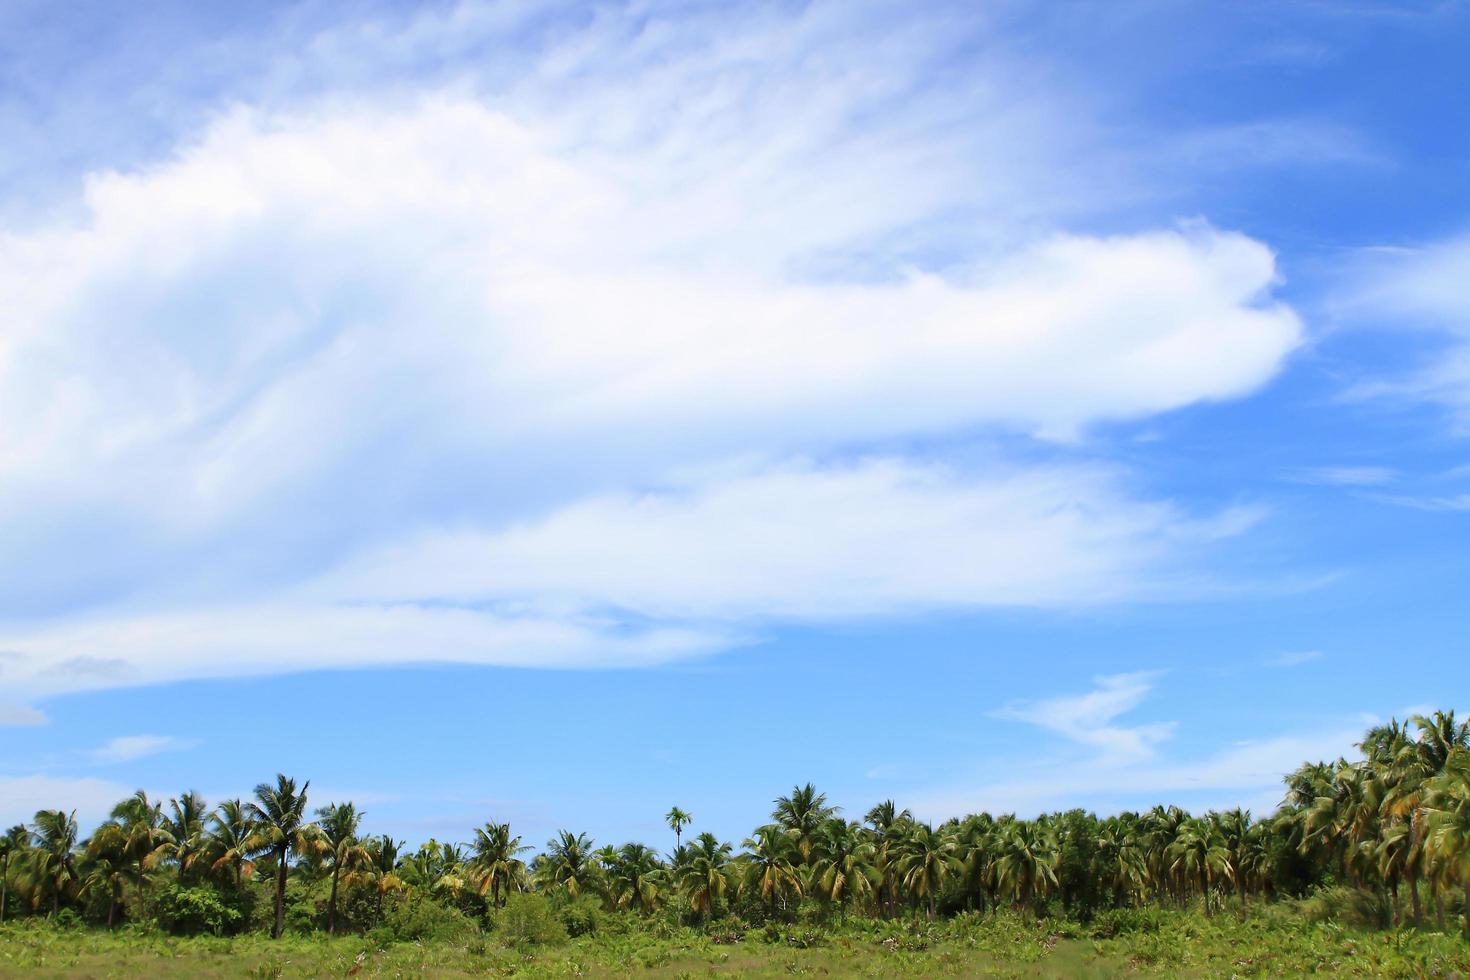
[0,713,1470,936]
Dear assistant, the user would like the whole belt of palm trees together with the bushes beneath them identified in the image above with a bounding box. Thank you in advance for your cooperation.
[0,713,1470,968]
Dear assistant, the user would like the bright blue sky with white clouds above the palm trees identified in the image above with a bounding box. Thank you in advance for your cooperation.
[0,0,1470,846]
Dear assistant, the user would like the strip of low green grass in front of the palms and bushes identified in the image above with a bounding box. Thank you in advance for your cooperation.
[0,907,1470,977]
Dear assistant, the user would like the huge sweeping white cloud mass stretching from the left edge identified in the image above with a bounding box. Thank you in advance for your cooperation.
[0,7,1301,695]
